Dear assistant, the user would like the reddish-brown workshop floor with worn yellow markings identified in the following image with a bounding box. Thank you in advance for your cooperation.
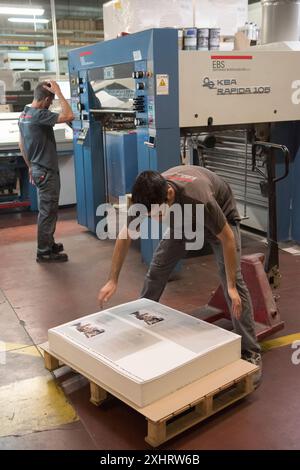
[0,209,300,450]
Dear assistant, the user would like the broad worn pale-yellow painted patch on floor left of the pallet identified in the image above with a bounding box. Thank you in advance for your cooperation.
[0,376,78,437]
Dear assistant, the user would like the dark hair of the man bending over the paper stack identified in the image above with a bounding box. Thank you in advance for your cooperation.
[132,171,168,212]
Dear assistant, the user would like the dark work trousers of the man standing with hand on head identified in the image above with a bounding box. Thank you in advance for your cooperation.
[32,165,60,255]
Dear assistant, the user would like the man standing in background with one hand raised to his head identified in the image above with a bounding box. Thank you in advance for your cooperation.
[19,80,74,262]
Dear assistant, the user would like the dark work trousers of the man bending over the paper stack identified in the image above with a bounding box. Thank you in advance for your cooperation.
[141,224,260,353]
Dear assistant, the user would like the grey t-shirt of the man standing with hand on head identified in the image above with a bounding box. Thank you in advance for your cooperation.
[19,106,58,171]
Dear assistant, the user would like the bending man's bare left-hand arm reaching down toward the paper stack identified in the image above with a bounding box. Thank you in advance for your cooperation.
[98,226,131,308]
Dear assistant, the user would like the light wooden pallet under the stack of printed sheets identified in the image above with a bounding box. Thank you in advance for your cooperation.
[41,343,258,447]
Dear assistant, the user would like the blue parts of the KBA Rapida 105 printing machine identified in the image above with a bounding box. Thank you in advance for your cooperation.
[69,29,300,263]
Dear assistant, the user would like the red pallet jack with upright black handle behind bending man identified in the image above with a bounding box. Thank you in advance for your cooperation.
[193,142,290,340]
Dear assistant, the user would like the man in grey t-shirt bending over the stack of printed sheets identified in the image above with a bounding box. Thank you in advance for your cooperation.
[98,165,261,385]
